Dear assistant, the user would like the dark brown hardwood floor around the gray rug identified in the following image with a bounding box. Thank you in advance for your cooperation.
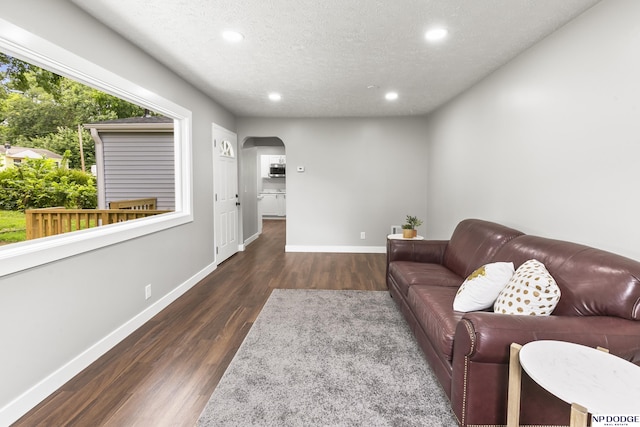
[14,221,387,427]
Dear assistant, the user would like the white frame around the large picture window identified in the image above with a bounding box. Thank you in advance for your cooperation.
[0,18,193,277]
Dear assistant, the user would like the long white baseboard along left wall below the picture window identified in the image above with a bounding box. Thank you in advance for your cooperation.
[0,264,216,426]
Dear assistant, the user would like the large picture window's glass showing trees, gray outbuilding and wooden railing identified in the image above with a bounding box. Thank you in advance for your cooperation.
[0,53,176,245]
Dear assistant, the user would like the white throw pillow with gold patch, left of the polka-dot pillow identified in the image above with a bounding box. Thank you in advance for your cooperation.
[453,262,514,312]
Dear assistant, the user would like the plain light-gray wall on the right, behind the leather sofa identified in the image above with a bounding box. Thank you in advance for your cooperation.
[427,0,640,259]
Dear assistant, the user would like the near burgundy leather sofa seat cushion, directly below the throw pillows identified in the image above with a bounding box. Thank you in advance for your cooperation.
[407,285,464,361]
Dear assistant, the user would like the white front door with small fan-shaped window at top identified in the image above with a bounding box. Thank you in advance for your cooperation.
[213,125,240,265]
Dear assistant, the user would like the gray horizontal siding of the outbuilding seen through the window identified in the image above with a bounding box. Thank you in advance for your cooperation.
[100,132,175,210]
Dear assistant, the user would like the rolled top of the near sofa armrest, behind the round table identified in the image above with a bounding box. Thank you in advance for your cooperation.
[454,312,640,369]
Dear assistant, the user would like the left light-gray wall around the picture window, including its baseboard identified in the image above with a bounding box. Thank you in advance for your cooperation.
[0,0,235,425]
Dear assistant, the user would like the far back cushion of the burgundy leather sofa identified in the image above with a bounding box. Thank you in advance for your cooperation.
[444,219,522,277]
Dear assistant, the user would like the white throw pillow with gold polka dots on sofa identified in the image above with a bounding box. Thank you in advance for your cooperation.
[493,259,560,316]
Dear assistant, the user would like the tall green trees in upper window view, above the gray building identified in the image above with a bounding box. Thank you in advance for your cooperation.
[0,53,144,168]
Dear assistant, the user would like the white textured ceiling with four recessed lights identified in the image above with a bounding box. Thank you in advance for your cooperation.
[71,0,599,117]
